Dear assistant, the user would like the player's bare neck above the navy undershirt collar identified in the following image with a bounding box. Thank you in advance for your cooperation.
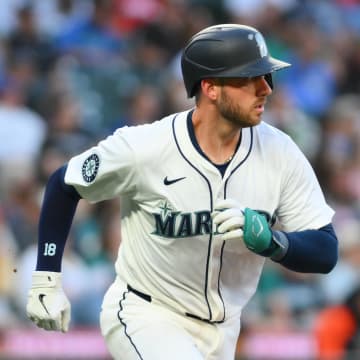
[192,109,241,164]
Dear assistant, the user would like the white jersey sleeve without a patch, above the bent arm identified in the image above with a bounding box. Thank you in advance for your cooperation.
[277,138,334,231]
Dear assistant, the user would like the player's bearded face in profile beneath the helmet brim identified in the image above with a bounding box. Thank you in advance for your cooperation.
[217,76,272,127]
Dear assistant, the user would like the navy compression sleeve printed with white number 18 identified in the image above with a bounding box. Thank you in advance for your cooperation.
[36,165,80,272]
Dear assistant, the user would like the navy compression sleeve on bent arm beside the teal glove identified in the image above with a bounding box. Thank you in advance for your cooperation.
[278,224,338,274]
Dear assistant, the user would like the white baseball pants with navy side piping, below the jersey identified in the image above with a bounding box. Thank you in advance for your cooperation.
[100,278,240,360]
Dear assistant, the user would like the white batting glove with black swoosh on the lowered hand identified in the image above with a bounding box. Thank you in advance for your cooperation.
[26,271,71,332]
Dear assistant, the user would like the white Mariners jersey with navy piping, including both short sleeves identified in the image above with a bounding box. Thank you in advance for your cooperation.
[65,111,334,322]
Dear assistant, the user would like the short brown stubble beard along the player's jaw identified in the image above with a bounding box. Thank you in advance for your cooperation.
[218,89,261,128]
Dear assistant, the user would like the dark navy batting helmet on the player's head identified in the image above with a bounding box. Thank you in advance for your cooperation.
[181,24,290,97]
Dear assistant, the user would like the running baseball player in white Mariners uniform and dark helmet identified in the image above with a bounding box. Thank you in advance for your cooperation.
[27,24,337,360]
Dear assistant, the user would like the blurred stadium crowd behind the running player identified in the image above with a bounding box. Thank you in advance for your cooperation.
[0,0,360,360]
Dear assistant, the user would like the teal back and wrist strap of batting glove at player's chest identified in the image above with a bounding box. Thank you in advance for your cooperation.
[243,208,289,261]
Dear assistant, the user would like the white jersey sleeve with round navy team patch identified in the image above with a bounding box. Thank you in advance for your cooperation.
[65,128,137,203]
